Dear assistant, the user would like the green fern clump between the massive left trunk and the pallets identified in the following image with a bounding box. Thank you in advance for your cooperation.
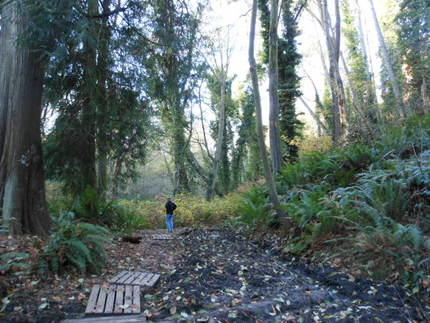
[39,212,110,273]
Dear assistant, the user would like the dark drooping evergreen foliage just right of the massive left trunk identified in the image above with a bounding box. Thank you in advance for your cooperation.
[43,0,151,196]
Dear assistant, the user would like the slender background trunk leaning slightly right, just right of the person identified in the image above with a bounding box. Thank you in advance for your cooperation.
[206,68,226,201]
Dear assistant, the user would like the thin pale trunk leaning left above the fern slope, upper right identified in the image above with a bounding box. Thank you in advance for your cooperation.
[369,0,407,118]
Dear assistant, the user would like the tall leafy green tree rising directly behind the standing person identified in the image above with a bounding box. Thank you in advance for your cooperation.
[145,0,204,194]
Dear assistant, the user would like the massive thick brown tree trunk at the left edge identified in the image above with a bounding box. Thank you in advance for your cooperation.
[0,0,51,235]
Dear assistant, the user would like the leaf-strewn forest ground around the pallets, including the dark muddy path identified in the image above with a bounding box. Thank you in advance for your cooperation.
[0,228,430,322]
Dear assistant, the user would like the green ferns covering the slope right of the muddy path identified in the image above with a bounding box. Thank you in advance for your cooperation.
[235,115,430,292]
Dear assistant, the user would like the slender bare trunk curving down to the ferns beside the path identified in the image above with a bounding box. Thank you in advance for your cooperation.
[248,0,283,216]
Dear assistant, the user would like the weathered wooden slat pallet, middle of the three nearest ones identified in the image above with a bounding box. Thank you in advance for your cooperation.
[85,285,141,315]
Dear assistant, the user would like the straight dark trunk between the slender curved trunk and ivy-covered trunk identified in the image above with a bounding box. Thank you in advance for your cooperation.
[269,0,282,174]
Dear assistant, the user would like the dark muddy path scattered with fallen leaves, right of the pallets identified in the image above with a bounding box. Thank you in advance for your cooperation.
[140,229,425,322]
